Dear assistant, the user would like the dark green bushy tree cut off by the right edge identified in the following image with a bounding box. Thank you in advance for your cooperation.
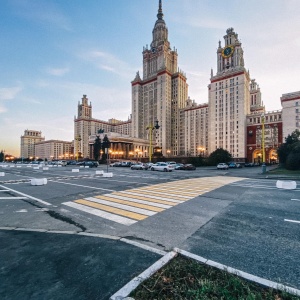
[277,129,300,170]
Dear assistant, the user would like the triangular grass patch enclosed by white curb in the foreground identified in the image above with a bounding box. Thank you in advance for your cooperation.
[130,254,300,300]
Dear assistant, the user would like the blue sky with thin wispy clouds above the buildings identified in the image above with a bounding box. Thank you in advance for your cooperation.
[0,0,300,155]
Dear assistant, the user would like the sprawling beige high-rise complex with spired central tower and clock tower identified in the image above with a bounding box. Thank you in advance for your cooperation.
[74,0,300,162]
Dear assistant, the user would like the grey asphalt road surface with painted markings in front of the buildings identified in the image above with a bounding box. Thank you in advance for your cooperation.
[0,166,300,299]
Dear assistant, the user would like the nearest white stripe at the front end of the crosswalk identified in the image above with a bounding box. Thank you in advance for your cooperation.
[62,202,137,226]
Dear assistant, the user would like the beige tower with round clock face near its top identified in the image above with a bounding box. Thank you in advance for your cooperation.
[208,28,252,161]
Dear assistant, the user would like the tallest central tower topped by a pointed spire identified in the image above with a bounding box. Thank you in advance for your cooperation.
[131,0,188,155]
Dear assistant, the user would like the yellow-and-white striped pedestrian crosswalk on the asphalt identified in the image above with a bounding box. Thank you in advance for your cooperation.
[63,176,245,225]
